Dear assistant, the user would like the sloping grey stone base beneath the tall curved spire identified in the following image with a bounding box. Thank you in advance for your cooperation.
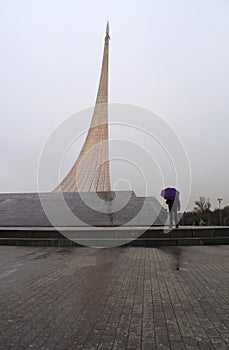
[0,191,167,227]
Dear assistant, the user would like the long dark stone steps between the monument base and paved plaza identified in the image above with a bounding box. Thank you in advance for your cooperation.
[0,227,229,247]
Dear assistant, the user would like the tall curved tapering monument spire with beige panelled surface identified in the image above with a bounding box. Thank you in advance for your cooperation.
[54,22,111,192]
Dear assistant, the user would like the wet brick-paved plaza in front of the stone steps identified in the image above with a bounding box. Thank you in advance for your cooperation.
[0,246,229,350]
